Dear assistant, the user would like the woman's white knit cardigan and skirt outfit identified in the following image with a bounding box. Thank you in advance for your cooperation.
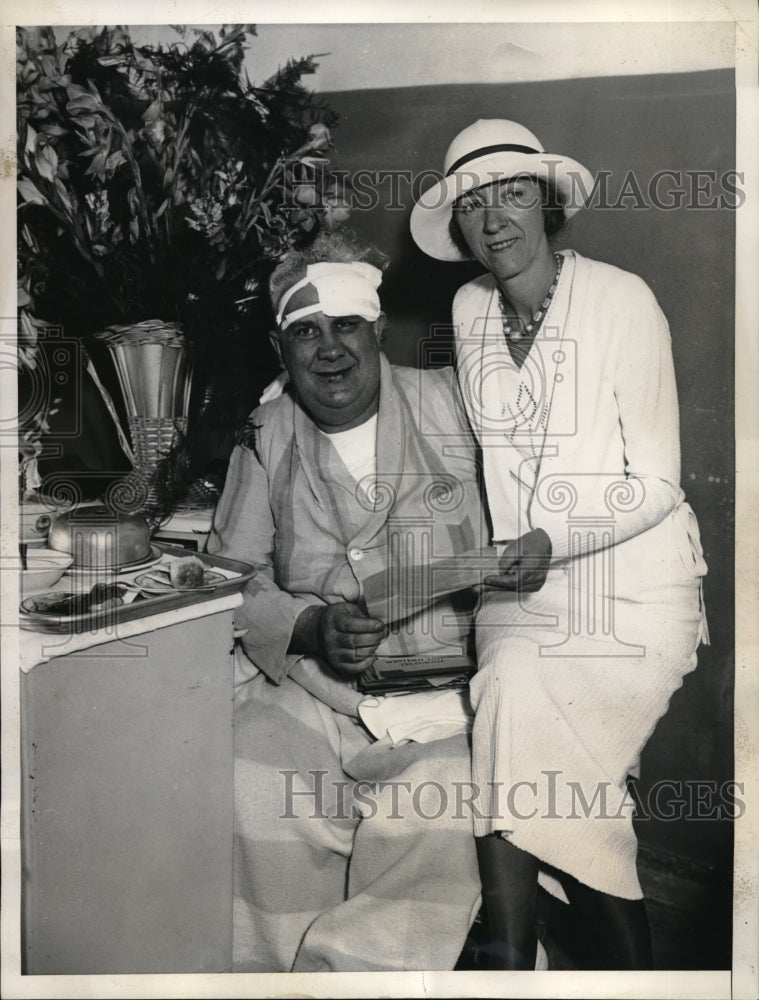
[453,251,708,899]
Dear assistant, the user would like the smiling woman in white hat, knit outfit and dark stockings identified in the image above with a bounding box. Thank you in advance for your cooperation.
[411,119,708,969]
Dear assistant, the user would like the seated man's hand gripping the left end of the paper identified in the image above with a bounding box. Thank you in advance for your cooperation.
[290,603,387,677]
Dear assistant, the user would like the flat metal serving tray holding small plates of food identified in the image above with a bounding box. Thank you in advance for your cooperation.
[19,542,256,635]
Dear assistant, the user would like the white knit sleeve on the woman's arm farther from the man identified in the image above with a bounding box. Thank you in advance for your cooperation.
[532,275,683,561]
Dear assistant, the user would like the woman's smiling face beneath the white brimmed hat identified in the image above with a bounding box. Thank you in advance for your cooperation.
[453,177,550,281]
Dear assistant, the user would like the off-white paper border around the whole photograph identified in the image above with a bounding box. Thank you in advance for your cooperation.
[0,0,759,1000]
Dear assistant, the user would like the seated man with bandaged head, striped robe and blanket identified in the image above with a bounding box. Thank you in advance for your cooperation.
[208,232,487,972]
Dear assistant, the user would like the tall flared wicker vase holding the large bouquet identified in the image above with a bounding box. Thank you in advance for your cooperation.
[96,320,192,508]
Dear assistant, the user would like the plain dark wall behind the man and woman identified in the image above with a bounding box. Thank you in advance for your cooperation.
[324,70,735,865]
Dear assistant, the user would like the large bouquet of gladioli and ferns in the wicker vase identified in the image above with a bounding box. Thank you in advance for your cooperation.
[17,24,348,516]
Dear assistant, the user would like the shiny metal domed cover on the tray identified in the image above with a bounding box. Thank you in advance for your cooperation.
[47,504,151,570]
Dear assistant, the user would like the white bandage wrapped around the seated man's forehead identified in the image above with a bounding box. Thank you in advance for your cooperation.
[277,260,382,330]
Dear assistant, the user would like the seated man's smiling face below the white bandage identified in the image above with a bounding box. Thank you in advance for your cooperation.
[272,287,385,433]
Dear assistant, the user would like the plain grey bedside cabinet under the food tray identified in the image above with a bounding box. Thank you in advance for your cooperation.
[21,594,241,975]
